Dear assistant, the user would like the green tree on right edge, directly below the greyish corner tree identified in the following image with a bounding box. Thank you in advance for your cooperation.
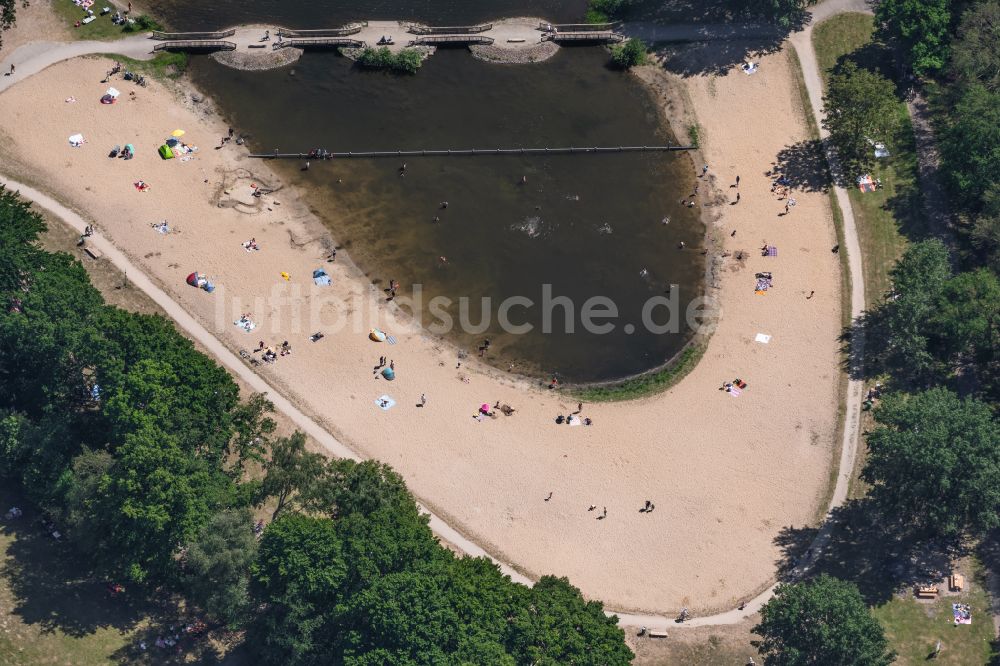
[939,83,1000,213]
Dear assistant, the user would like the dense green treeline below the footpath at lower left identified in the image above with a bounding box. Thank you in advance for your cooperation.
[0,189,632,664]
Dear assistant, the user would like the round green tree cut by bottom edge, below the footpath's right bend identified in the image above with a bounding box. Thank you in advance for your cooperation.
[753,574,895,666]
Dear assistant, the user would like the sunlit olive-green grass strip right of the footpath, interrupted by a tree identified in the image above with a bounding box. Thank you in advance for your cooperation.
[813,14,925,307]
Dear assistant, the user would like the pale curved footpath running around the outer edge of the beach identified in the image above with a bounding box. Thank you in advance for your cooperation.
[0,0,868,627]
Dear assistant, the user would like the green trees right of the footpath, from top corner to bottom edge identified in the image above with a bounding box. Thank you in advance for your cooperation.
[754,0,1000,666]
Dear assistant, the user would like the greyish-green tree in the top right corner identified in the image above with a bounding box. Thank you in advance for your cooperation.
[951,0,1000,91]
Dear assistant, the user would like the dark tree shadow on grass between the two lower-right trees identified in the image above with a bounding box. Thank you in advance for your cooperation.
[775,498,968,605]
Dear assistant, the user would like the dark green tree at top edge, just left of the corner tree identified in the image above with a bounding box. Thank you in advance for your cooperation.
[875,0,952,76]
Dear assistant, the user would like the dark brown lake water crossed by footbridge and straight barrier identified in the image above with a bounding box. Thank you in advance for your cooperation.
[165,0,704,381]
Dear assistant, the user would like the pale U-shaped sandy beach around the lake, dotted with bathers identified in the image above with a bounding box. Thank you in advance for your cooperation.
[0,53,841,613]
